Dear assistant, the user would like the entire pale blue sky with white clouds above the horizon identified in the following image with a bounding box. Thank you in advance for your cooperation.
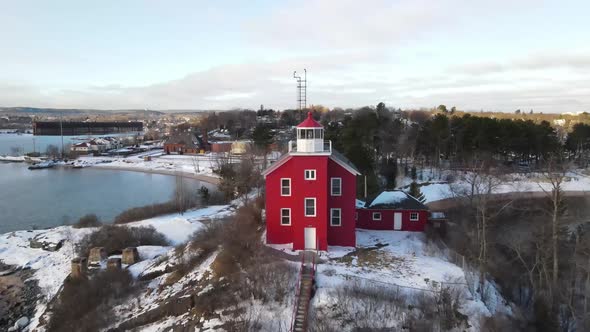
[0,0,590,112]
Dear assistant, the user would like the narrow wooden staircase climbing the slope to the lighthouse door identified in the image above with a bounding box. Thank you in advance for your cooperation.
[291,251,316,332]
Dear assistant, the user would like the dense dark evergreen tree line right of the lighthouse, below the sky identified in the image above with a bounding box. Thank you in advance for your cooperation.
[300,103,590,193]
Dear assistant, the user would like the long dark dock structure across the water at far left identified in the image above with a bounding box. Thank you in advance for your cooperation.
[33,121,143,136]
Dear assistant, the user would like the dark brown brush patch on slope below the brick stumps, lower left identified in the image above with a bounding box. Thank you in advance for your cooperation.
[48,270,137,332]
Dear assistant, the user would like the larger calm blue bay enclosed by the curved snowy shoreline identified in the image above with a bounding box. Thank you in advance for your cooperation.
[0,163,214,234]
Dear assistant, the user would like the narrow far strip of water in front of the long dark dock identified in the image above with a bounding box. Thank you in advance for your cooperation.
[0,133,135,156]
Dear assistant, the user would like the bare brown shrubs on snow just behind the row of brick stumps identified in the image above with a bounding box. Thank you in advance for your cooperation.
[78,225,169,256]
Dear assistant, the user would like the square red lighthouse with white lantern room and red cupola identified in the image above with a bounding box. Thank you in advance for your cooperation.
[263,113,360,250]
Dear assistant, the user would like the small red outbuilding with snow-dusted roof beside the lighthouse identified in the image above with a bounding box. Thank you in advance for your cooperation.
[356,190,429,232]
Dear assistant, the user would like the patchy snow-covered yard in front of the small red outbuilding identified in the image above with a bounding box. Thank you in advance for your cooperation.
[312,230,512,331]
